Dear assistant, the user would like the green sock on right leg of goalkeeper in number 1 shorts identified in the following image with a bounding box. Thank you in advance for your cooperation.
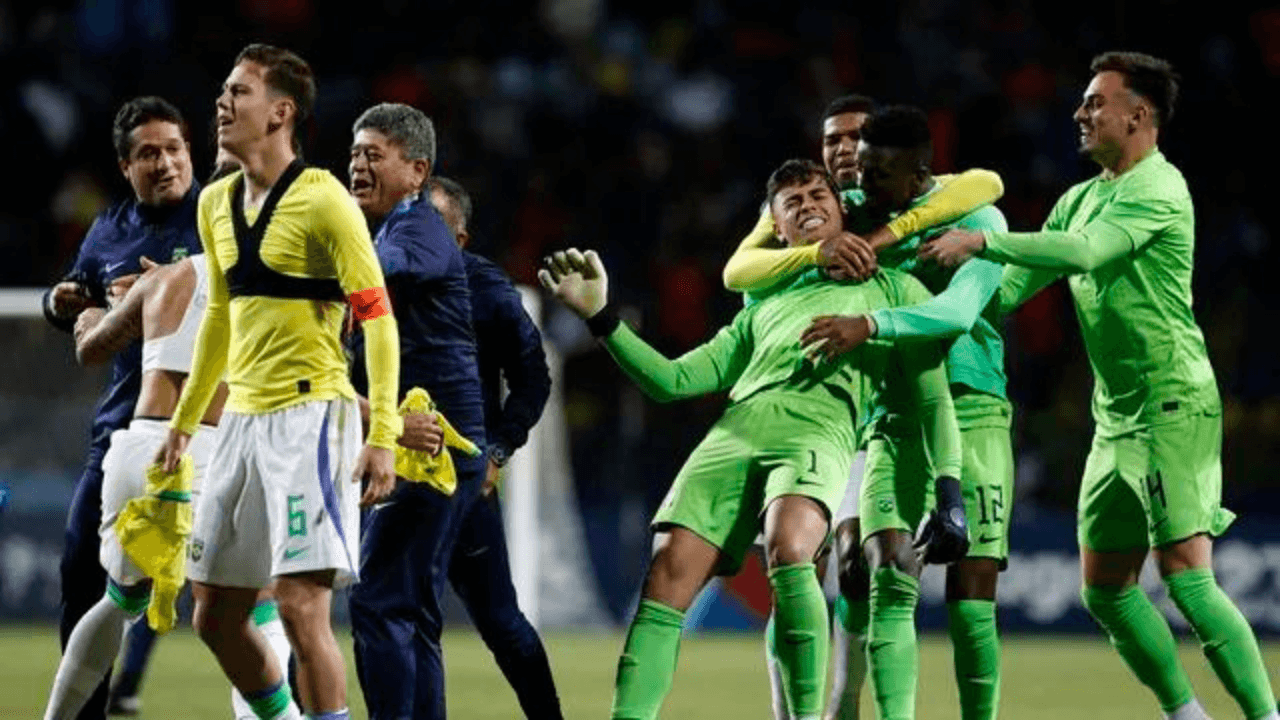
[769,562,831,717]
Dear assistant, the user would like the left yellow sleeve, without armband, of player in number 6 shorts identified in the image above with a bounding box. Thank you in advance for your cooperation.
[170,184,232,434]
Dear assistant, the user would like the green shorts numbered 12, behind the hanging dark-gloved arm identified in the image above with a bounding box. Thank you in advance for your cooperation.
[859,392,1014,569]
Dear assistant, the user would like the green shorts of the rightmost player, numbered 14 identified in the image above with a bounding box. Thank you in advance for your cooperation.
[1076,407,1235,552]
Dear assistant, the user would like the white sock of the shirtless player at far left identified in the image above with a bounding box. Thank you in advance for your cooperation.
[45,594,134,720]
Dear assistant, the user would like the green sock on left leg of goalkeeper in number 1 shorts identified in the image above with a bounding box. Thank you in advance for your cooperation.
[609,600,685,720]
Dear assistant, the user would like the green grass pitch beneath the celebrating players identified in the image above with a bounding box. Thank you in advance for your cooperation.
[0,626,1280,720]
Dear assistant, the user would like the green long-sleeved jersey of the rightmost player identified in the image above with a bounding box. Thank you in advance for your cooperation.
[982,149,1220,434]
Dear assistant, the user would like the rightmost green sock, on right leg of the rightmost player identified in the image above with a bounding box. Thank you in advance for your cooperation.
[1165,568,1276,720]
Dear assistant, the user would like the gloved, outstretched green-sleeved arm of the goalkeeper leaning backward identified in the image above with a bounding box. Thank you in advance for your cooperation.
[538,249,750,402]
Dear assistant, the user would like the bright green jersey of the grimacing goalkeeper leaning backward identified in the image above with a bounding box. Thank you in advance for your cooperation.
[604,270,961,477]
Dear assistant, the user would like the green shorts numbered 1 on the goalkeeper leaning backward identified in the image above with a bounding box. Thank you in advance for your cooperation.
[653,387,856,574]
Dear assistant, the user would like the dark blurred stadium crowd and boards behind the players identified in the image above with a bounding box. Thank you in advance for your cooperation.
[0,0,1280,655]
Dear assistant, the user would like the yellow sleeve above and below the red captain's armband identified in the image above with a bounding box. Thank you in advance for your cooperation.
[314,178,404,450]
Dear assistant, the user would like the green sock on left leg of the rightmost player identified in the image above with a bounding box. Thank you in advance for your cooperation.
[1080,585,1196,712]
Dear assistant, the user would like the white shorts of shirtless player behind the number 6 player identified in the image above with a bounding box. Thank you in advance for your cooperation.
[97,419,218,587]
